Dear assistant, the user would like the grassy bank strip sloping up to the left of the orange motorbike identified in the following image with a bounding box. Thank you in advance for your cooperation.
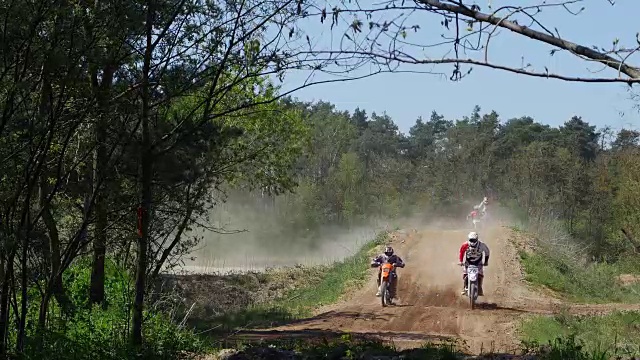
[201,232,388,331]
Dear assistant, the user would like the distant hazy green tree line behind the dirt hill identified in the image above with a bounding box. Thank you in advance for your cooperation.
[272,102,640,260]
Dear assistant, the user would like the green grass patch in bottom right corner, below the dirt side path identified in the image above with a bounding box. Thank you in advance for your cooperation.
[521,311,640,359]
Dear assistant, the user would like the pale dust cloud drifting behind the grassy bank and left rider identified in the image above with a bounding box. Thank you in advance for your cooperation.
[176,194,502,274]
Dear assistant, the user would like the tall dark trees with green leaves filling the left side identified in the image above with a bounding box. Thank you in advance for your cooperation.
[0,0,307,357]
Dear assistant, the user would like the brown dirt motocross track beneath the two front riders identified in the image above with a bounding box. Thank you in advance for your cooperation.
[229,221,640,354]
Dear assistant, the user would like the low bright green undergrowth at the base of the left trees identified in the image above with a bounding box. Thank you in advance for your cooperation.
[21,259,205,360]
